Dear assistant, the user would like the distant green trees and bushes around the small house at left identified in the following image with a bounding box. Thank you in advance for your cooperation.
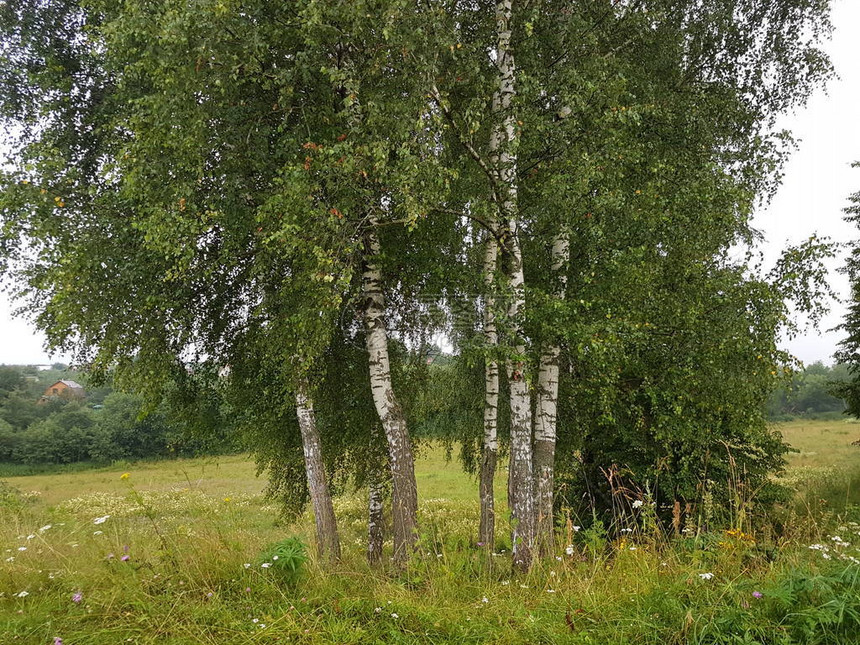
[0,365,234,465]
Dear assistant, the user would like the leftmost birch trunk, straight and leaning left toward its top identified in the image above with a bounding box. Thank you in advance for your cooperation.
[296,383,340,561]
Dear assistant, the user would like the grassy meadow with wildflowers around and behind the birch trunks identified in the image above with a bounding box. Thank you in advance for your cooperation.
[0,422,860,645]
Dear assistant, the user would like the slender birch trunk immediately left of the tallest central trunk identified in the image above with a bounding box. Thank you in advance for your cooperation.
[478,234,499,550]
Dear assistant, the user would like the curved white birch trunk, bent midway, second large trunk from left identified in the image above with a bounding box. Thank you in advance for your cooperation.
[362,216,418,563]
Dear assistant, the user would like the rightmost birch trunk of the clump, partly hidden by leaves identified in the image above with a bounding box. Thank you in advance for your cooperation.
[534,231,570,557]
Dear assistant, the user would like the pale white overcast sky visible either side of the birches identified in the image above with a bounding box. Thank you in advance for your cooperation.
[0,0,860,364]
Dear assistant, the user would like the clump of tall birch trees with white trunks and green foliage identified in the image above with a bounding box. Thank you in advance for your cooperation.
[0,0,831,571]
